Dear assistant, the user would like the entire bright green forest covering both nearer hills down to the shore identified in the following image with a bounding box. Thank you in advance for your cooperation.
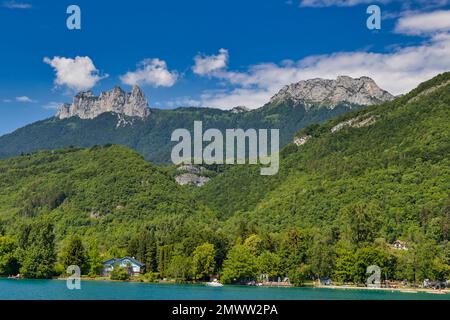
[0,73,450,285]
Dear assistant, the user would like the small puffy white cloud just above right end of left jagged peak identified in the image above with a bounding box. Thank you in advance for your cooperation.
[120,59,179,87]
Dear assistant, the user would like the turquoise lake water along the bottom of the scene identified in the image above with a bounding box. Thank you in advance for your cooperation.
[0,279,450,300]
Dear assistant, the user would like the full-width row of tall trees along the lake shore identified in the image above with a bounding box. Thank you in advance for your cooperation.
[0,208,450,286]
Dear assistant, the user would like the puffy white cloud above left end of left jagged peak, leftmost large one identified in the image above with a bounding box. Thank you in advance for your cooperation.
[44,56,108,91]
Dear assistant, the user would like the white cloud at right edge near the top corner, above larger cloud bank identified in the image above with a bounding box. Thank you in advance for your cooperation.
[395,10,450,35]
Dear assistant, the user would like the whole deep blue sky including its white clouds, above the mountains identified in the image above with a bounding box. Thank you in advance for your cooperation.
[0,0,450,135]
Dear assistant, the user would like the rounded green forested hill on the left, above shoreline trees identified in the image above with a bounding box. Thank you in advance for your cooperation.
[0,146,223,247]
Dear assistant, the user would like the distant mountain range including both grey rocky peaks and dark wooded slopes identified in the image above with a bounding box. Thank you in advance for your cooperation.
[0,76,394,164]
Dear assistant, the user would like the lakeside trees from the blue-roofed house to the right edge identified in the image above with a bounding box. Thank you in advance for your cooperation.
[126,203,450,285]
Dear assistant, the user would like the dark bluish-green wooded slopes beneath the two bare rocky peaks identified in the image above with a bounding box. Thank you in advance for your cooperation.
[0,101,359,164]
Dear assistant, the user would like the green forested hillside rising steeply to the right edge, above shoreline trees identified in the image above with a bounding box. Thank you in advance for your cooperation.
[199,74,450,232]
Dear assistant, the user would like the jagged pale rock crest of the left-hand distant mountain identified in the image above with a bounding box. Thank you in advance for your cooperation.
[56,86,150,119]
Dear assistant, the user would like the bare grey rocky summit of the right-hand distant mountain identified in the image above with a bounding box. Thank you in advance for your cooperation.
[271,76,395,109]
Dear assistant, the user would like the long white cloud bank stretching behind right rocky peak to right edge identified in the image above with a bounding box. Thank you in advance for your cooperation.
[202,34,450,109]
